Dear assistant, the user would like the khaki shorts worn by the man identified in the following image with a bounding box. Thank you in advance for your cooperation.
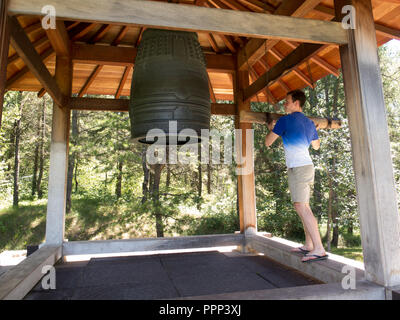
[288,164,315,203]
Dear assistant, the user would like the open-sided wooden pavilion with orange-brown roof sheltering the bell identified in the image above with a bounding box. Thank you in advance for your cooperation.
[0,0,400,299]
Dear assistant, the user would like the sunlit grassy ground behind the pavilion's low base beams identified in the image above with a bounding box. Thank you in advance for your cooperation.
[0,196,363,261]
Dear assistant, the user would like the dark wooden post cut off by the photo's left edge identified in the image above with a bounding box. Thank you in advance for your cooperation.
[0,0,10,128]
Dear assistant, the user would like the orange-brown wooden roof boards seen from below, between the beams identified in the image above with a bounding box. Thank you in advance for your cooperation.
[6,0,400,103]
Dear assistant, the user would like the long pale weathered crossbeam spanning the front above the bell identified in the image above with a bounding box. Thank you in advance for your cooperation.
[9,0,347,44]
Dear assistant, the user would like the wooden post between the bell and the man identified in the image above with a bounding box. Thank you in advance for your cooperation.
[234,71,257,234]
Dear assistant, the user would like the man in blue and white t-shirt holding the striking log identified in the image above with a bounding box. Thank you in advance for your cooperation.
[265,90,328,262]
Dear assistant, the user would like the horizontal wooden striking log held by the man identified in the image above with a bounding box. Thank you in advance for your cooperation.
[240,111,342,129]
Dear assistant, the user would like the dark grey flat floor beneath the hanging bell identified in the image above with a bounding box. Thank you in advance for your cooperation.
[25,251,320,300]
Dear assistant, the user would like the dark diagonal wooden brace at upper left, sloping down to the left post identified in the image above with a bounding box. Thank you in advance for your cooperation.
[10,17,64,105]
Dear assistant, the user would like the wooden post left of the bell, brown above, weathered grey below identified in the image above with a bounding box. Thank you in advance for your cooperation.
[46,56,72,245]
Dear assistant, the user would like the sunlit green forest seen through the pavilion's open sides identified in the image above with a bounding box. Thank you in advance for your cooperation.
[0,41,400,261]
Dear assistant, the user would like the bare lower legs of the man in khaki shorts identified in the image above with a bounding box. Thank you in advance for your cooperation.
[294,202,325,256]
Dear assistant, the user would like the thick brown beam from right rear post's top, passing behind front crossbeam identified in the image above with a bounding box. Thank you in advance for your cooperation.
[238,0,321,70]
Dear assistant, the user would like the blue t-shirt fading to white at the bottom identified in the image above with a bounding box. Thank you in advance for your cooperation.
[272,112,318,168]
